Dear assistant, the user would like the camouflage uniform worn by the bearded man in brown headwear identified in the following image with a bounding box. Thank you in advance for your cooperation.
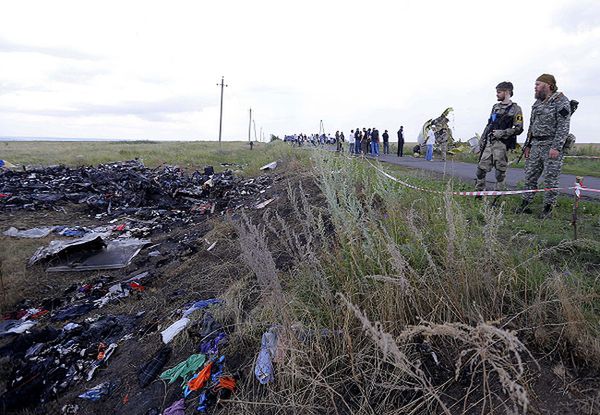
[523,92,571,206]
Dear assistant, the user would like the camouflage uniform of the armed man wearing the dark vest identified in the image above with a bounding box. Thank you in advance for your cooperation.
[475,102,523,191]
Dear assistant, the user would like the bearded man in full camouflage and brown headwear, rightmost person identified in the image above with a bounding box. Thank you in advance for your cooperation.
[519,74,571,218]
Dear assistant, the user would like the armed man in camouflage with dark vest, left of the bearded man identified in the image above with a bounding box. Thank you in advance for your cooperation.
[475,82,523,191]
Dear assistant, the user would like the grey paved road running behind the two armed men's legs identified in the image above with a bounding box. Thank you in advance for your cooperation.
[340,150,600,200]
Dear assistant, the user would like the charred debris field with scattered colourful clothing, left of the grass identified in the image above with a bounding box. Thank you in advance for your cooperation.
[0,160,281,414]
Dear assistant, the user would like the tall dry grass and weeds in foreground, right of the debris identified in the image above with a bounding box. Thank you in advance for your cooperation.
[217,153,600,414]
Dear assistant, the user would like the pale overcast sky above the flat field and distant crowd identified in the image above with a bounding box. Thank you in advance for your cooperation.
[0,0,600,142]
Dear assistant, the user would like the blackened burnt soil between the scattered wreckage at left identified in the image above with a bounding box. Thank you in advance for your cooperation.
[0,158,324,414]
